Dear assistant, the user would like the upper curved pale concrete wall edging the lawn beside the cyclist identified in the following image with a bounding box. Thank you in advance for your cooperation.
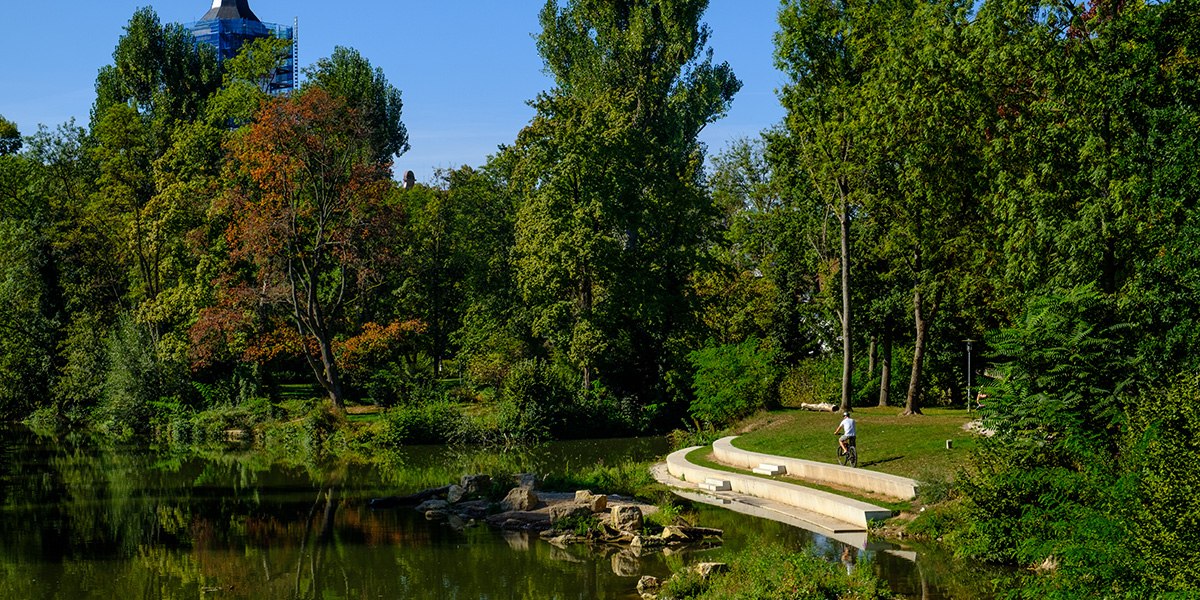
[713,436,917,500]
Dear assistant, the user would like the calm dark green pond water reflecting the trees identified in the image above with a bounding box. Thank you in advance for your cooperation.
[0,427,982,600]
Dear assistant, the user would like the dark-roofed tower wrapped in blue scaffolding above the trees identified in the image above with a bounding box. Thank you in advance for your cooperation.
[186,0,300,94]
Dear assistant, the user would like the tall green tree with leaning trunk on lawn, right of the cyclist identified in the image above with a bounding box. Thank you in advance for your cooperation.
[863,1,983,414]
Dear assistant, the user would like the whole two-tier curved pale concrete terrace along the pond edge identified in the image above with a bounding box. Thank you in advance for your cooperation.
[654,437,917,537]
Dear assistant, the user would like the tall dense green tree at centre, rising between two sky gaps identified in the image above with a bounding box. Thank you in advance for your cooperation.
[516,0,740,394]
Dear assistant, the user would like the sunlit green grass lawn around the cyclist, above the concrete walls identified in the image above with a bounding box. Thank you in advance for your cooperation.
[733,407,976,480]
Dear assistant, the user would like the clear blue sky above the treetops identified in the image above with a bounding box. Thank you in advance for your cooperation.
[0,0,784,181]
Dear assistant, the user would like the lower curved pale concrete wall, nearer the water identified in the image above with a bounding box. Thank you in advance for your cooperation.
[667,446,892,529]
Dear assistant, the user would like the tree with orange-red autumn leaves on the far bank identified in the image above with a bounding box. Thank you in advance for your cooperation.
[213,86,397,408]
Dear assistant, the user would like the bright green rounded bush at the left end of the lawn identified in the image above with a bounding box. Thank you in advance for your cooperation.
[688,337,776,426]
